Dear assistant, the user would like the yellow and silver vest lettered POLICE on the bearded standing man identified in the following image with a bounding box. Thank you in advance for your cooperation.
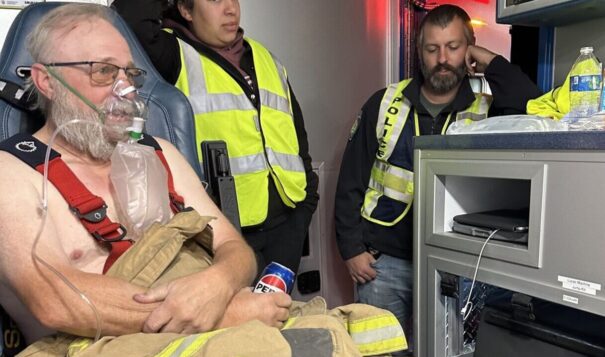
[361,77,492,226]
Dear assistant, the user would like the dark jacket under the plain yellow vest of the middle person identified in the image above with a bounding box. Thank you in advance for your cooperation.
[112,0,319,228]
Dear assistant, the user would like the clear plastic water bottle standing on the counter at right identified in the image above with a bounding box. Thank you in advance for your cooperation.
[569,47,603,118]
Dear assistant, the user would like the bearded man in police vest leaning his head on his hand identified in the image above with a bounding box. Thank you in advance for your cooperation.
[335,5,539,354]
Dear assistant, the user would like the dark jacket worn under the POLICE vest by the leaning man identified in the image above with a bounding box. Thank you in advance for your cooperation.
[335,56,540,260]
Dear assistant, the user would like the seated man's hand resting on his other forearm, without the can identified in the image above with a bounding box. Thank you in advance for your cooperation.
[133,267,235,333]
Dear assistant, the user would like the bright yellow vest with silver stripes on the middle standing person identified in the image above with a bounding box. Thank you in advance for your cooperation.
[176,38,307,227]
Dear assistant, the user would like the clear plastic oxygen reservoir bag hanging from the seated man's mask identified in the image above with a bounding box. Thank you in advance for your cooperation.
[109,84,172,239]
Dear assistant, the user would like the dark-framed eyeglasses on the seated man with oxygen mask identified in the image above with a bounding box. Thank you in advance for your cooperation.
[45,61,147,88]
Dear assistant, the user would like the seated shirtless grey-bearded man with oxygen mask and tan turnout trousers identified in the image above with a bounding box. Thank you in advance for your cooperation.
[0,4,405,356]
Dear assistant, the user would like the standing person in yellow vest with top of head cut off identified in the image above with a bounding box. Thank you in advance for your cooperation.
[112,0,319,272]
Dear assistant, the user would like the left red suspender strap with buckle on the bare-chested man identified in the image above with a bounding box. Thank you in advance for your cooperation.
[36,156,132,273]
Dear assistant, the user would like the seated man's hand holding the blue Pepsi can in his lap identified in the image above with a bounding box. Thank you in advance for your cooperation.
[217,288,292,328]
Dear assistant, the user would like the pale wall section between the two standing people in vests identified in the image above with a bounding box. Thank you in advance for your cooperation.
[240,0,398,306]
